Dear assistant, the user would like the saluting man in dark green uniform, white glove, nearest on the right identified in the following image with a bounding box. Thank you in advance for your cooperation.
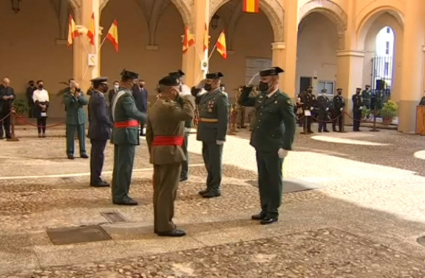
[239,67,296,225]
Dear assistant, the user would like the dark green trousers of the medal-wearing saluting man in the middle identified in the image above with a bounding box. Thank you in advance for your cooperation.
[202,141,223,191]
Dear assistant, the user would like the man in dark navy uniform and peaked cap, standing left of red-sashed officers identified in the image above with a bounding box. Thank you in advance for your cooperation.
[88,77,112,187]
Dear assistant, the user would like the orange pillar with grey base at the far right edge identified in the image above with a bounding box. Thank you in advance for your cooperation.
[398,0,425,132]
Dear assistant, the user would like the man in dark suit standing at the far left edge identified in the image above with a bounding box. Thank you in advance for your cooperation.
[0,78,16,140]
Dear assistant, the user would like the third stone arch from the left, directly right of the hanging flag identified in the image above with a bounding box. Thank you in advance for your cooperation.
[298,0,348,50]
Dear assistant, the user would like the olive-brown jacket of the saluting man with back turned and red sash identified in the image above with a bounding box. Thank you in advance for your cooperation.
[146,95,195,165]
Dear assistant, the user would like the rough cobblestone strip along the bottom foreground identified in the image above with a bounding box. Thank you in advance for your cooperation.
[9,229,425,278]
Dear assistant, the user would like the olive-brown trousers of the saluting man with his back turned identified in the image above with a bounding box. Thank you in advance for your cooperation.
[153,163,182,233]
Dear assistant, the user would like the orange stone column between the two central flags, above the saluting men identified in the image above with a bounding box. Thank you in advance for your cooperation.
[182,1,210,87]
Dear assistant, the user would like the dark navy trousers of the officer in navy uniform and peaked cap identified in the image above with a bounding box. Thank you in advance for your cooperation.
[90,139,107,185]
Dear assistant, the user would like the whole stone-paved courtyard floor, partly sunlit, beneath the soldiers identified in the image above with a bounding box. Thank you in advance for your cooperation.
[0,126,425,278]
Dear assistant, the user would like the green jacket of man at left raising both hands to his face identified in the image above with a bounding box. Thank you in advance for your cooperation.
[63,89,88,125]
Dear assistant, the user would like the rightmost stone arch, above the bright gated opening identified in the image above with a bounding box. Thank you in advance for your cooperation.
[356,0,404,49]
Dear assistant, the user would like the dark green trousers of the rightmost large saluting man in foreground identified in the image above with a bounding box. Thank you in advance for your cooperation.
[256,150,283,218]
